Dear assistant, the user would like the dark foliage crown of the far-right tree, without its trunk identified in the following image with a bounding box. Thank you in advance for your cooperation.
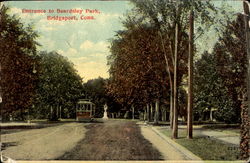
[214,15,247,121]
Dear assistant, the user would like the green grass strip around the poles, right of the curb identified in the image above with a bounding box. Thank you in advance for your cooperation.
[162,129,239,161]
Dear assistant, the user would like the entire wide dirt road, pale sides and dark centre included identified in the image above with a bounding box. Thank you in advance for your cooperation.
[1,119,191,161]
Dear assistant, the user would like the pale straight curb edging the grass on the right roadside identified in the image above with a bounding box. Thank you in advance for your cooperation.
[150,127,202,161]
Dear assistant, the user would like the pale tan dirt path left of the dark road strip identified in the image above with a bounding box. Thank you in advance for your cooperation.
[1,123,86,160]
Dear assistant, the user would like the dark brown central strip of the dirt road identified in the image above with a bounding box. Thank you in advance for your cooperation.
[57,120,162,160]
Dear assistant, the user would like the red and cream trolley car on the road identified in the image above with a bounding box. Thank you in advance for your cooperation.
[76,99,95,121]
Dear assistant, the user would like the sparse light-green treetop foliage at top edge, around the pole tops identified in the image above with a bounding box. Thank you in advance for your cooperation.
[131,0,217,39]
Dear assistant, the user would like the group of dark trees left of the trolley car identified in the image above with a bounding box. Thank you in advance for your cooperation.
[0,6,83,120]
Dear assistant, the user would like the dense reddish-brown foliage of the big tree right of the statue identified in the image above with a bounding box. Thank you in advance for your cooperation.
[109,25,166,104]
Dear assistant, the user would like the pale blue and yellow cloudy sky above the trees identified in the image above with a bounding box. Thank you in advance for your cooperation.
[5,1,241,82]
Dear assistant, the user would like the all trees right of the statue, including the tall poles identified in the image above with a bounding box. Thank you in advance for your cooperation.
[107,0,247,158]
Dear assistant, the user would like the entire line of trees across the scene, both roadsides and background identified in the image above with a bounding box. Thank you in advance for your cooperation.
[0,0,249,157]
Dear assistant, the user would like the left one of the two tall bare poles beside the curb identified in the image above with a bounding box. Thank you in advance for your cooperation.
[172,21,179,139]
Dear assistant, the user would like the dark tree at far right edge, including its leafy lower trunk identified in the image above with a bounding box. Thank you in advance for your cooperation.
[214,13,249,159]
